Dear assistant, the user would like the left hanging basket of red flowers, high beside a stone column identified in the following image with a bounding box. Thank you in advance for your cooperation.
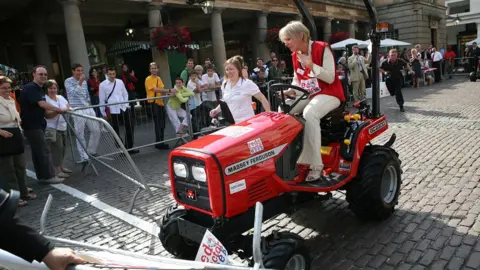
[152,25,192,52]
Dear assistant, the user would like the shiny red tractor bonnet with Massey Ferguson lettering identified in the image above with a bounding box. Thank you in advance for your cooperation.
[181,112,303,175]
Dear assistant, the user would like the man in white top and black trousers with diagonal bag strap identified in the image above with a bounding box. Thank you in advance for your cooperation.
[98,68,139,154]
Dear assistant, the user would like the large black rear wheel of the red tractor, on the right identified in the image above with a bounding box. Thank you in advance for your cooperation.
[347,146,402,220]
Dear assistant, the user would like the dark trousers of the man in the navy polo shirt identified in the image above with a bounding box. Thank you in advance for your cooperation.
[23,129,55,180]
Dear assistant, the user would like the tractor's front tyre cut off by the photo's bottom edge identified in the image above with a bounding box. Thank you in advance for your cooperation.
[263,232,311,270]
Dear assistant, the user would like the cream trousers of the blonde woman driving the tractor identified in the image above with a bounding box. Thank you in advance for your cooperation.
[296,95,341,168]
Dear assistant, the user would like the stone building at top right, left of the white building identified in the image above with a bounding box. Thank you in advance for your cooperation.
[374,0,446,49]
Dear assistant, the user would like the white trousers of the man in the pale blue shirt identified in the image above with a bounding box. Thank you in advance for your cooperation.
[73,109,101,160]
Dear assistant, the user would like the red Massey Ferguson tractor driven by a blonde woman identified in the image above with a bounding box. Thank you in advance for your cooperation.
[159,0,402,269]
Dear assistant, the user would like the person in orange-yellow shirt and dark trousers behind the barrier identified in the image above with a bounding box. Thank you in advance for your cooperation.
[145,62,172,150]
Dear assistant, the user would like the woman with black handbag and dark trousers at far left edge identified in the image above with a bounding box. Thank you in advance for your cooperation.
[0,76,37,206]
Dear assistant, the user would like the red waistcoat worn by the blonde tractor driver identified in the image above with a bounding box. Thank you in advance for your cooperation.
[292,41,345,102]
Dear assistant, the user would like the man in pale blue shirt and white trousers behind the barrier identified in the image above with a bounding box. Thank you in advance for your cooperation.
[65,64,100,162]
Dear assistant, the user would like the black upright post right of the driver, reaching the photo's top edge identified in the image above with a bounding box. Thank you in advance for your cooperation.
[363,0,380,118]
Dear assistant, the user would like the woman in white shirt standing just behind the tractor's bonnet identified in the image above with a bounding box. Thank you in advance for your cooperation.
[210,55,270,123]
